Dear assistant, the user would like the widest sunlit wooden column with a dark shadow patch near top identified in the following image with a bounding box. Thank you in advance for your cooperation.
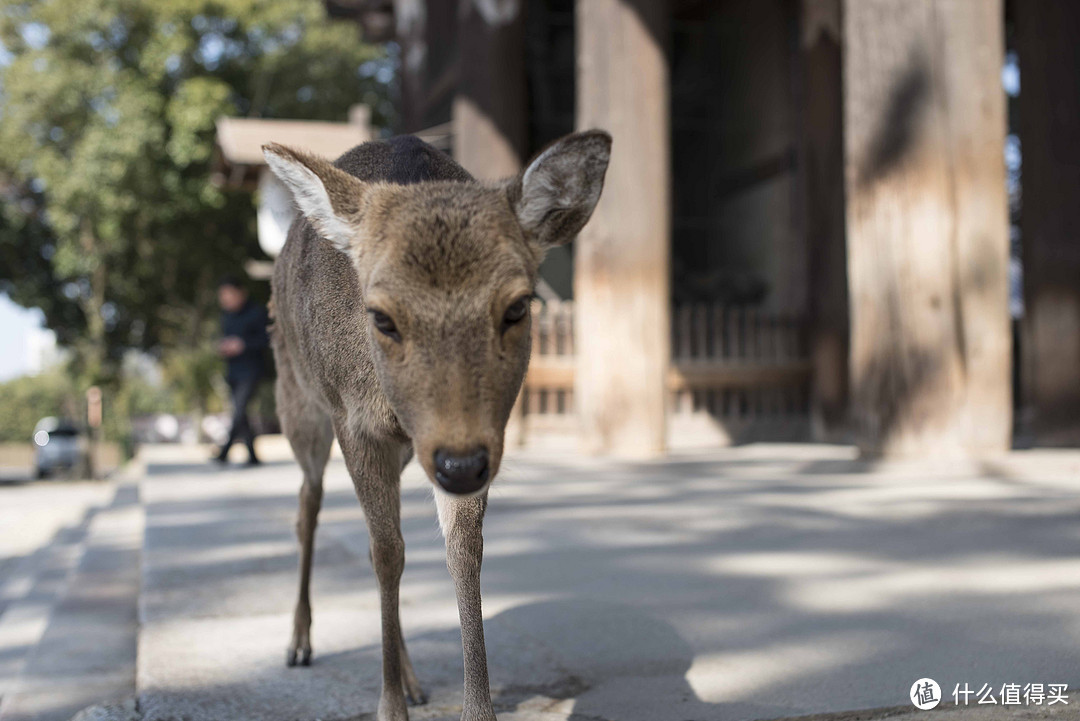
[843,0,1012,455]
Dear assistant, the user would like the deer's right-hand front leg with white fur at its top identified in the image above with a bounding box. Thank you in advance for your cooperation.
[435,490,496,721]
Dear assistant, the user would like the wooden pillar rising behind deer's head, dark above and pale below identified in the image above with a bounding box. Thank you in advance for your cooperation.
[454,0,528,178]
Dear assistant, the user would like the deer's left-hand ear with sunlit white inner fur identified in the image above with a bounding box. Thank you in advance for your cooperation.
[262,142,365,253]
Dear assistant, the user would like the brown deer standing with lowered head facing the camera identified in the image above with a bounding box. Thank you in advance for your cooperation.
[262,131,611,721]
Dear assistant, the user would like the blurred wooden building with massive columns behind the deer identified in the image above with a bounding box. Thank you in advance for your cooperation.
[291,0,1080,455]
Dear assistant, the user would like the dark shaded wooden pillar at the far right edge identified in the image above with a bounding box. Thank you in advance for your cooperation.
[1013,0,1080,443]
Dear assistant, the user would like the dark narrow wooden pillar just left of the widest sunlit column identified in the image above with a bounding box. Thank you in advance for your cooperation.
[797,0,850,440]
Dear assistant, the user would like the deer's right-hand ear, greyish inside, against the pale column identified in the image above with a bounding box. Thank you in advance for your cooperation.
[510,131,611,248]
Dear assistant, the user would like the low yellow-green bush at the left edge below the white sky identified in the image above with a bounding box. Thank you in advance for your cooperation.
[0,370,82,443]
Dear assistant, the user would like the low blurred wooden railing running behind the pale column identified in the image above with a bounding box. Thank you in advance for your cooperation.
[518,302,810,442]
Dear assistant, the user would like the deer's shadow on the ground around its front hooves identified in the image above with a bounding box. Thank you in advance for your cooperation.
[315,598,789,721]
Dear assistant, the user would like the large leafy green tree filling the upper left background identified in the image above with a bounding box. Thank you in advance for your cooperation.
[0,0,391,382]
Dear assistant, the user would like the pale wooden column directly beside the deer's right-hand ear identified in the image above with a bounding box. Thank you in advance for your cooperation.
[573,0,671,457]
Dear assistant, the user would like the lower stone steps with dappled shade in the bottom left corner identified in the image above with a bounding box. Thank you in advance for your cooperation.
[0,478,143,721]
